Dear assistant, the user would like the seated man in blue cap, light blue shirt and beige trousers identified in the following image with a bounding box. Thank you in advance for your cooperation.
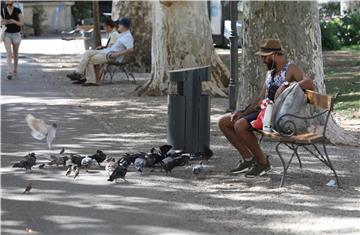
[67,18,134,86]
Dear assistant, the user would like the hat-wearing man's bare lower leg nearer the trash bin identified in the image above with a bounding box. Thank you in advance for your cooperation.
[218,113,253,158]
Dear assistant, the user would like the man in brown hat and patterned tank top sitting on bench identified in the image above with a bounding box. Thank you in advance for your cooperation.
[218,39,313,177]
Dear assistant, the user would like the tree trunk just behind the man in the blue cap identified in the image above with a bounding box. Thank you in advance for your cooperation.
[112,0,152,73]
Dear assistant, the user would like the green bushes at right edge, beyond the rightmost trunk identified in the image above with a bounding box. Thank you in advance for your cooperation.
[320,12,360,50]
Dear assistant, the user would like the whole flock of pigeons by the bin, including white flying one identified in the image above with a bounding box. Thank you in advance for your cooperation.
[13,114,213,193]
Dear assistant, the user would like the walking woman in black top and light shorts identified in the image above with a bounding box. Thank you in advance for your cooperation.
[1,0,24,80]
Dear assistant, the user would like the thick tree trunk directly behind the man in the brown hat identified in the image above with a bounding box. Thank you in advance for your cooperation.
[237,1,356,144]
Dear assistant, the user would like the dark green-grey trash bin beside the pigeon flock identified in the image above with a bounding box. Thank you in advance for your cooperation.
[167,66,210,153]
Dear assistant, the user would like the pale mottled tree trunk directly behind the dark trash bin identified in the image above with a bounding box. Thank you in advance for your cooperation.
[137,1,229,96]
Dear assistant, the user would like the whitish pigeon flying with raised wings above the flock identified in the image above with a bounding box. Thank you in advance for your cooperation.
[25,114,57,149]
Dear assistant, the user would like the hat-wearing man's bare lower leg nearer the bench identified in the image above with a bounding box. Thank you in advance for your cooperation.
[234,118,267,164]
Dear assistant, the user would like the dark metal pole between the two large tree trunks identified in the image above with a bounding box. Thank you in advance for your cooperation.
[228,0,238,111]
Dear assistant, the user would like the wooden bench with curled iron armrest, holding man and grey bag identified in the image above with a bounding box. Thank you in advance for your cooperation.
[255,90,341,187]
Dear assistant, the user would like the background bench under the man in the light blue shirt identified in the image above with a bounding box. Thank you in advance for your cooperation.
[100,58,136,84]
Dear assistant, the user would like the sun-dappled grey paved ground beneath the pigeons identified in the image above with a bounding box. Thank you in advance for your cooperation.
[1,39,360,235]
